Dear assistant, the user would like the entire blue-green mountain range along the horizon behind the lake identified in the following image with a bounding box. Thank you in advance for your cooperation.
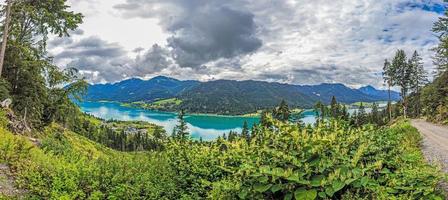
[85,76,400,114]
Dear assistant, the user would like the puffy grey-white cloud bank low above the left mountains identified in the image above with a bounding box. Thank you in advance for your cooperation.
[51,37,172,82]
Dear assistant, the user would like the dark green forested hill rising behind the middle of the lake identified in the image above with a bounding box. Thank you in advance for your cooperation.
[179,80,314,114]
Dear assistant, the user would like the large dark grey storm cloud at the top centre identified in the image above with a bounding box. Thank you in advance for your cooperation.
[115,0,262,68]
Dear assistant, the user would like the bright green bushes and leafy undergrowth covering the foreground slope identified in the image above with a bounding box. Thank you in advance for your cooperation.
[0,117,443,199]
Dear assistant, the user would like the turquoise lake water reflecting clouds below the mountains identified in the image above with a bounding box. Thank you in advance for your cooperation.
[78,102,315,140]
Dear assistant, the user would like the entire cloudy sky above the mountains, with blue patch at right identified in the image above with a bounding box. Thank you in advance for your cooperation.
[49,0,444,87]
